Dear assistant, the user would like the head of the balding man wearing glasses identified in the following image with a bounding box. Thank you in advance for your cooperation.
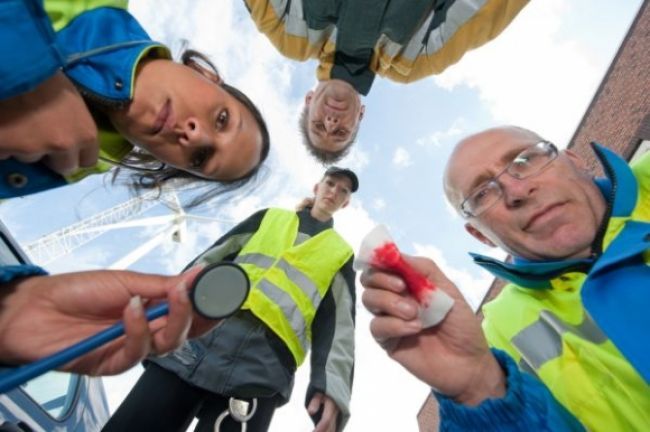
[444,126,605,260]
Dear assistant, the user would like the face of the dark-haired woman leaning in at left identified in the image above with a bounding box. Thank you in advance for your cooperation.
[109,59,262,180]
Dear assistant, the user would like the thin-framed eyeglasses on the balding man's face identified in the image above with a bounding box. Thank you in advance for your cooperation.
[460,141,558,218]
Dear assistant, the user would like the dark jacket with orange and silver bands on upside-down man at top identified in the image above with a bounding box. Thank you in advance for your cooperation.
[245,0,528,95]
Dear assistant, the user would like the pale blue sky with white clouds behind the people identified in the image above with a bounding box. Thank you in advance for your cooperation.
[0,0,642,432]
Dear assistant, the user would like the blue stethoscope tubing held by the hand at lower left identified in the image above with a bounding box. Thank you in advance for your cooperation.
[0,302,169,394]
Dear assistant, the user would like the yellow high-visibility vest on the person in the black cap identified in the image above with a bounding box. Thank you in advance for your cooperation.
[235,209,352,366]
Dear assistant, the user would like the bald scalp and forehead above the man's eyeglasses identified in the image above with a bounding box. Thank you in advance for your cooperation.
[443,126,543,211]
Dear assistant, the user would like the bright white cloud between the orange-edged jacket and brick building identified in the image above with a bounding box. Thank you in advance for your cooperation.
[432,0,603,145]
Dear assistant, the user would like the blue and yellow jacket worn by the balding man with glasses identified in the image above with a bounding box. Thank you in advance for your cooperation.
[439,145,650,431]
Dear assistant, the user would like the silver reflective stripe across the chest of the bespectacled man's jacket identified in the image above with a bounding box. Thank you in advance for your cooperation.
[512,310,607,370]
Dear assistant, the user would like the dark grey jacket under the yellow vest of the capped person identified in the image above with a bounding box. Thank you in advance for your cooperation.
[150,210,355,427]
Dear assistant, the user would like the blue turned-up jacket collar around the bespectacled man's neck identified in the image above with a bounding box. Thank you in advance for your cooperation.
[470,142,638,289]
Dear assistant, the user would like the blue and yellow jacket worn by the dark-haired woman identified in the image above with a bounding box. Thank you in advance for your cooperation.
[0,0,171,199]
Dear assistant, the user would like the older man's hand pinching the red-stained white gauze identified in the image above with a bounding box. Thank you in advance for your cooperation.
[361,257,505,405]
